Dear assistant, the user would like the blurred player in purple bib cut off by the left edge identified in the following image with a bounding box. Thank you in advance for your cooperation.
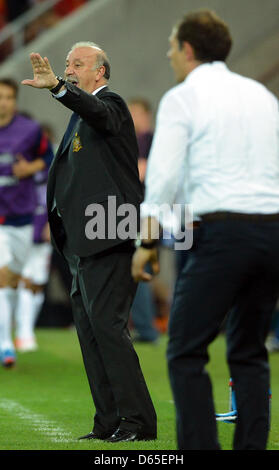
[0,78,53,366]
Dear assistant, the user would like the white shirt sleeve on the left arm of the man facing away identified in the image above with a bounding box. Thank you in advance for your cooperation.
[141,92,190,217]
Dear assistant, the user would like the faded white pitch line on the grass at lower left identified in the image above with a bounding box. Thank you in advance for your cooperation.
[0,398,75,442]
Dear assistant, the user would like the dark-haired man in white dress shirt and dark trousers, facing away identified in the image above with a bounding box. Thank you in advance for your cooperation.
[132,10,279,449]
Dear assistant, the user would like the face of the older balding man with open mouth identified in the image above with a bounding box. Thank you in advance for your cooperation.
[65,47,100,93]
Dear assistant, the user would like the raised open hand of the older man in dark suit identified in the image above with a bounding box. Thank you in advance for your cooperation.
[21,52,58,90]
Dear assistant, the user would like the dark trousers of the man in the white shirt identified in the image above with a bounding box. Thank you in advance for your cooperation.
[167,220,279,449]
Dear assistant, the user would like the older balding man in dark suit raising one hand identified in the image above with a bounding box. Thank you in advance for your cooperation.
[22,42,156,442]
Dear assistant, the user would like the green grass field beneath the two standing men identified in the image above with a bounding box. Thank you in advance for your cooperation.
[0,329,279,450]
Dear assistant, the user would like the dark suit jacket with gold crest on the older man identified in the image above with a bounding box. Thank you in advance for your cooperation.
[47,83,142,256]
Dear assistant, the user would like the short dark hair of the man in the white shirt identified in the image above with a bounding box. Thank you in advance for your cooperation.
[175,10,232,62]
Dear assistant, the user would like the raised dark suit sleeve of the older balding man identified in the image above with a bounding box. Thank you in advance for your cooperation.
[53,83,127,135]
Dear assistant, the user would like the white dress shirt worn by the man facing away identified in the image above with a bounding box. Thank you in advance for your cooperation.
[141,62,279,217]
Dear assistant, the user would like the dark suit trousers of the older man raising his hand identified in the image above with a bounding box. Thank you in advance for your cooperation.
[64,243,156,436]
